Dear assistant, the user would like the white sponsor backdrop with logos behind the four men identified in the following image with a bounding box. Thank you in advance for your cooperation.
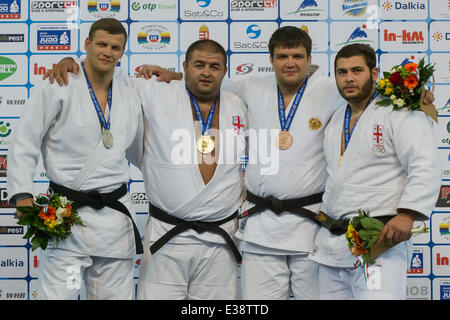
[0,0,450,300]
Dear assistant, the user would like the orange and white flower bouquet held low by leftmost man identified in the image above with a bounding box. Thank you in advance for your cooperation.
[16,189,84,251]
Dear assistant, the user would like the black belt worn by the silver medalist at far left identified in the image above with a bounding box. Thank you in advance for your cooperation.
[50,182,144,254]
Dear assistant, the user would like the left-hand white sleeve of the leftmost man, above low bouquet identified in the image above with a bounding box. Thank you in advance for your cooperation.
[8,81,63,201]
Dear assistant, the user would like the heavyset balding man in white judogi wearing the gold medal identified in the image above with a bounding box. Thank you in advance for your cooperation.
[135,40,246,299]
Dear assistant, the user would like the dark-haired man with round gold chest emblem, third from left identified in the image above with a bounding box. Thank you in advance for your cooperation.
[225,26,344,299]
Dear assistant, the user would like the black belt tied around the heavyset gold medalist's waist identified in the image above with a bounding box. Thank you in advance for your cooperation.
[149,203,242,263]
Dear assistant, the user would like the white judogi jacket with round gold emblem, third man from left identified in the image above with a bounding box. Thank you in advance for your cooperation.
[226,71,344,254]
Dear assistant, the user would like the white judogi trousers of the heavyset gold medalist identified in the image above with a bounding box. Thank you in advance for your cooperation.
[137,239,237,300]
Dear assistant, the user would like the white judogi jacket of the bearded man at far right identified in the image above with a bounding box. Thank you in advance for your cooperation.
[311,97,441,267]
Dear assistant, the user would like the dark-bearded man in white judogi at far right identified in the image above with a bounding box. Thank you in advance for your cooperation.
[311,44,441,300]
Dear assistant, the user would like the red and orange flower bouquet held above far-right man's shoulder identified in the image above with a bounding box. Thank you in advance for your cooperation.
[376,58,437,122]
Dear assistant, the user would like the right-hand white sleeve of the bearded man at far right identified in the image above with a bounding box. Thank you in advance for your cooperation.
[392,111,441,220]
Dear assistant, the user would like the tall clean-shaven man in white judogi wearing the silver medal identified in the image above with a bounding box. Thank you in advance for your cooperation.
[8,19,143,299]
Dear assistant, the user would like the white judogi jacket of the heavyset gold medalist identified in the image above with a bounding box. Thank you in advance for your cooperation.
[132,77,247,243]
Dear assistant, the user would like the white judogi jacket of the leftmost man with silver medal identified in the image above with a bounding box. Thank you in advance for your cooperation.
[8,66,143,258]
